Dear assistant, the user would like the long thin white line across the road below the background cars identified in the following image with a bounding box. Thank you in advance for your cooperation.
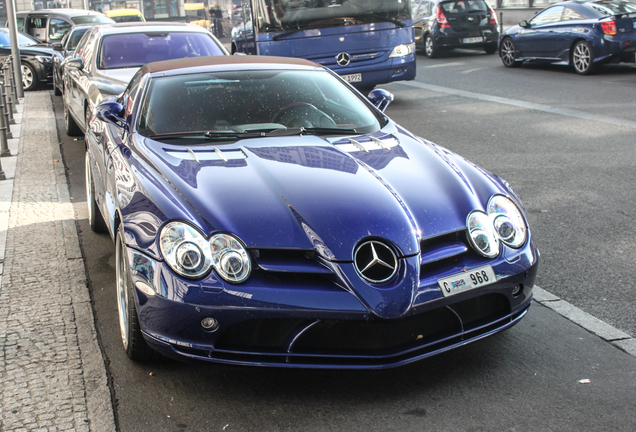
[395,80,636,129]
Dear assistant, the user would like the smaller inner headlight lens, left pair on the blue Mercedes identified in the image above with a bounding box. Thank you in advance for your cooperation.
[210,234,252,283]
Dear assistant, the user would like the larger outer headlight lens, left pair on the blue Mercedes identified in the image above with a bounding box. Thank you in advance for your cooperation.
[159,222,212,278]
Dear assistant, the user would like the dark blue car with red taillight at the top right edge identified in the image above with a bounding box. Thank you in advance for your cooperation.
[499,0,636,75]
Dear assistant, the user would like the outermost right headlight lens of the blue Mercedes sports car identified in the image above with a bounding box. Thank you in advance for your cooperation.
[488,195,528,248]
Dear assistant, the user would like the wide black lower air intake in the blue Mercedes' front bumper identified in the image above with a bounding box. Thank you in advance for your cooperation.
[215,294,510,356]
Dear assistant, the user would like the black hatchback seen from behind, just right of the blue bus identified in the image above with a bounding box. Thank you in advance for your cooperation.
[413,0,499,58]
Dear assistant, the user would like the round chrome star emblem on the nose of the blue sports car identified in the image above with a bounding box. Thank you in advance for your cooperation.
[353,240,398,283]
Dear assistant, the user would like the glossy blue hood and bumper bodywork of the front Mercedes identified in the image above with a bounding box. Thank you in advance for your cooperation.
[87,56,539,368]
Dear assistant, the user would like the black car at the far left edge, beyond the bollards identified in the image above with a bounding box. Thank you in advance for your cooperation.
[0,28,55,90]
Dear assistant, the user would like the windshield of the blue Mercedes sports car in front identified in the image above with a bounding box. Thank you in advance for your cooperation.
[138,70,381,138]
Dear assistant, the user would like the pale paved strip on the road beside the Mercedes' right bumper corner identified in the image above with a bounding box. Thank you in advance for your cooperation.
[533,285,636,357]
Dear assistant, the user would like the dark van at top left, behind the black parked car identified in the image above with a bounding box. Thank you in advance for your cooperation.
[12,9,115,43]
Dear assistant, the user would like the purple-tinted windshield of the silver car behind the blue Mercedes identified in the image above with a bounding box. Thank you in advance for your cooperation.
[98,32,224,69]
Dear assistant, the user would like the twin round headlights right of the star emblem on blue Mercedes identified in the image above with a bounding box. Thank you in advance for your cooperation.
[466,195,528,258]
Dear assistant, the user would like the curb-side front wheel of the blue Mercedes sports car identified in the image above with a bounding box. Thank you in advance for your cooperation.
[115,224,159,362]
